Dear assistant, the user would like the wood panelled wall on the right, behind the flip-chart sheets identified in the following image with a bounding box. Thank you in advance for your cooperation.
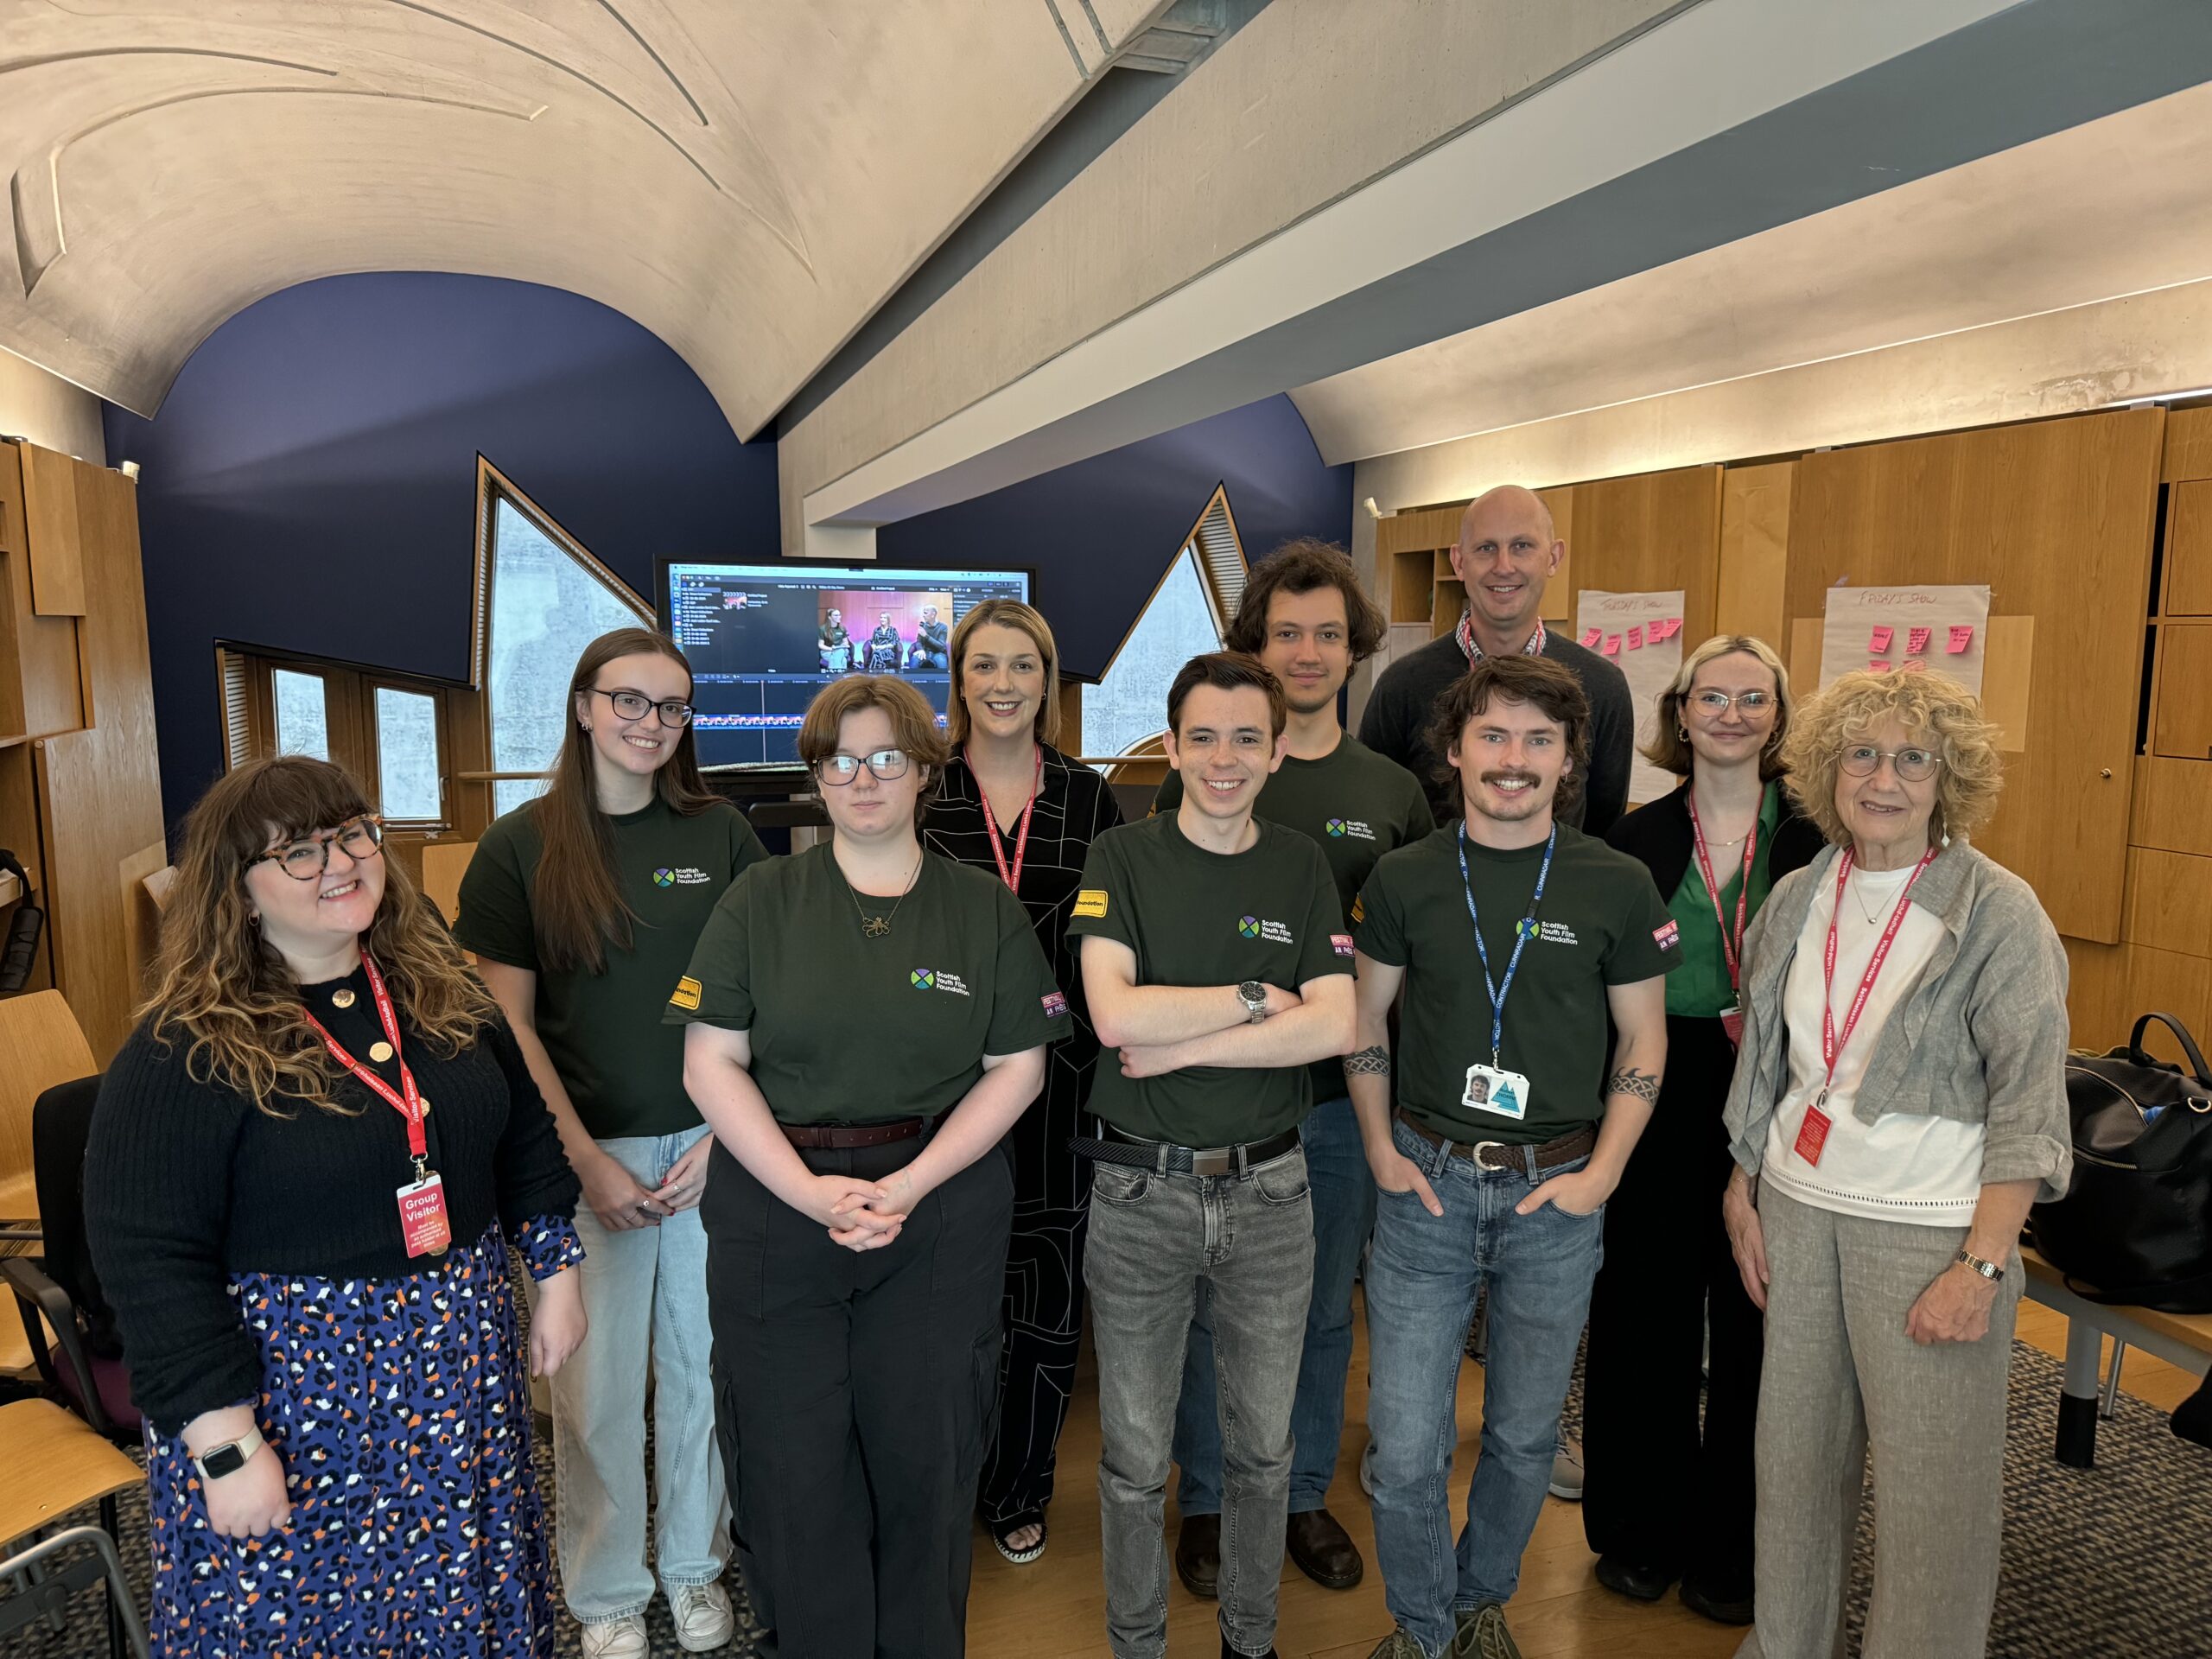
[1376,410,2212,1071]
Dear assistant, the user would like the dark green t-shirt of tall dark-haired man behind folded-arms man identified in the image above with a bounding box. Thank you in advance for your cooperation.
[1153,732,1435,1102]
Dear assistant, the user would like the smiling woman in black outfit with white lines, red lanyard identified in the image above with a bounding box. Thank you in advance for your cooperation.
[923,600,1122,1561]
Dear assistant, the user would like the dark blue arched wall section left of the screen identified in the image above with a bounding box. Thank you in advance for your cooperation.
[106,272,779,836]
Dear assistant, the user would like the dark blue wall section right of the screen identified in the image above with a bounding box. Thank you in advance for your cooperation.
[876,396,1351,677]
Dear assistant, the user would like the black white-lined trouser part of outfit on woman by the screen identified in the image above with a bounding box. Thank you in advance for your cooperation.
[978,1044,1090,1522]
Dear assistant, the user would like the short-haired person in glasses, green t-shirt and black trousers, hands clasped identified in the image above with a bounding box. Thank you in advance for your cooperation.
[668,675,1068,1659]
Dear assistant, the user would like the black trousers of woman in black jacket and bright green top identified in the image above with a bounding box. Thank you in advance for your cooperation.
[1581,1015,1763,1597]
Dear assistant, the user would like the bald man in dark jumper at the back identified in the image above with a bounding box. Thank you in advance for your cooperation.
[1360,485,1637,836]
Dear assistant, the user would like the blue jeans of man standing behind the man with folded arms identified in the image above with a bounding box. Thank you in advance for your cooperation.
[1174,1099,1376,1516]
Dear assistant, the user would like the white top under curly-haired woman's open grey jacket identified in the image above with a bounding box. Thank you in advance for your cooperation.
[1761,865,1982,1228]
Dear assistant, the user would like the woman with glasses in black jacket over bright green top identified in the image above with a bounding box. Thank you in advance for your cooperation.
[1581,635,1825,1624]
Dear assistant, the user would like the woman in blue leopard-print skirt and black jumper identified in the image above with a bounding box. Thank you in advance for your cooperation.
[84,754,584,1659]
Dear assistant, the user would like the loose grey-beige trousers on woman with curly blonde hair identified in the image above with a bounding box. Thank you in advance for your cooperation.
[1737,1185,2019,1659]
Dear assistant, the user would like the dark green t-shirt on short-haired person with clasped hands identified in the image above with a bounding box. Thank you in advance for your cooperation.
[664,841,1068,1123]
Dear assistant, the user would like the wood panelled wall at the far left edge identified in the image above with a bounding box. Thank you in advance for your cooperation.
[0,442,166,1064]
